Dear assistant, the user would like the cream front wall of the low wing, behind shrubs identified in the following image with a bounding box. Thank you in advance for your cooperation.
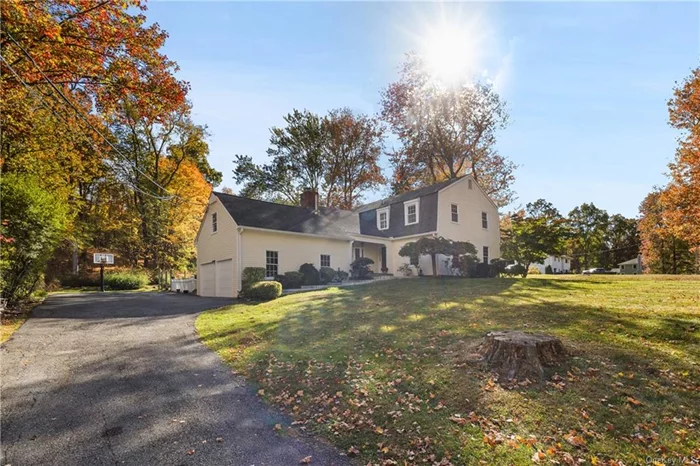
[240,227,351,274]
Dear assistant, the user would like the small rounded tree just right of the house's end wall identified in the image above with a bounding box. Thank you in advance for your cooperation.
[501,199,567,278]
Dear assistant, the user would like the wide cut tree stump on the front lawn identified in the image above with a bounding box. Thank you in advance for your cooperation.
[479,331,567,381]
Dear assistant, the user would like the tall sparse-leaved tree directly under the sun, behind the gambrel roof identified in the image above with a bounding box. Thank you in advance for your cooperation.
[381,54,516,206]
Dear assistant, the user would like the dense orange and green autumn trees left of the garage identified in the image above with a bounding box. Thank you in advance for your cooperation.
[0,0,221,306]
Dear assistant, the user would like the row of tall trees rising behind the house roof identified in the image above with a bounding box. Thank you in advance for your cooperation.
[234,54,516,209]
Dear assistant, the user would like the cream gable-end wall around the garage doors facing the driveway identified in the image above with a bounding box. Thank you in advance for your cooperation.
[197,194,240,294]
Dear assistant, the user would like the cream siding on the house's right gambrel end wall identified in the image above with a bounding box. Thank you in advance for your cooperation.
[434,177,501,260]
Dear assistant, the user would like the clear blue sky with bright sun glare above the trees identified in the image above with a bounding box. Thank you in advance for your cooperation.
[147,1,700,216]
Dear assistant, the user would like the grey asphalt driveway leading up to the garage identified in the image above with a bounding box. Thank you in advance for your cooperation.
[0,293,347,466]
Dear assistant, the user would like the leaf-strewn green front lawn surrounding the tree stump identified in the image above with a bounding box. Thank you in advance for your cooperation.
[196,276,700,466]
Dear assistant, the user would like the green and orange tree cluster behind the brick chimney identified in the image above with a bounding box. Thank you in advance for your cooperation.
[234,109,384,209]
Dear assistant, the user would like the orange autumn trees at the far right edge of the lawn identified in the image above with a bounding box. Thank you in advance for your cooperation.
[639,68,700,273]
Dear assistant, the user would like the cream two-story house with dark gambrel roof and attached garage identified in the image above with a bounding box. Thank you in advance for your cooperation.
[196,176,500,297]
